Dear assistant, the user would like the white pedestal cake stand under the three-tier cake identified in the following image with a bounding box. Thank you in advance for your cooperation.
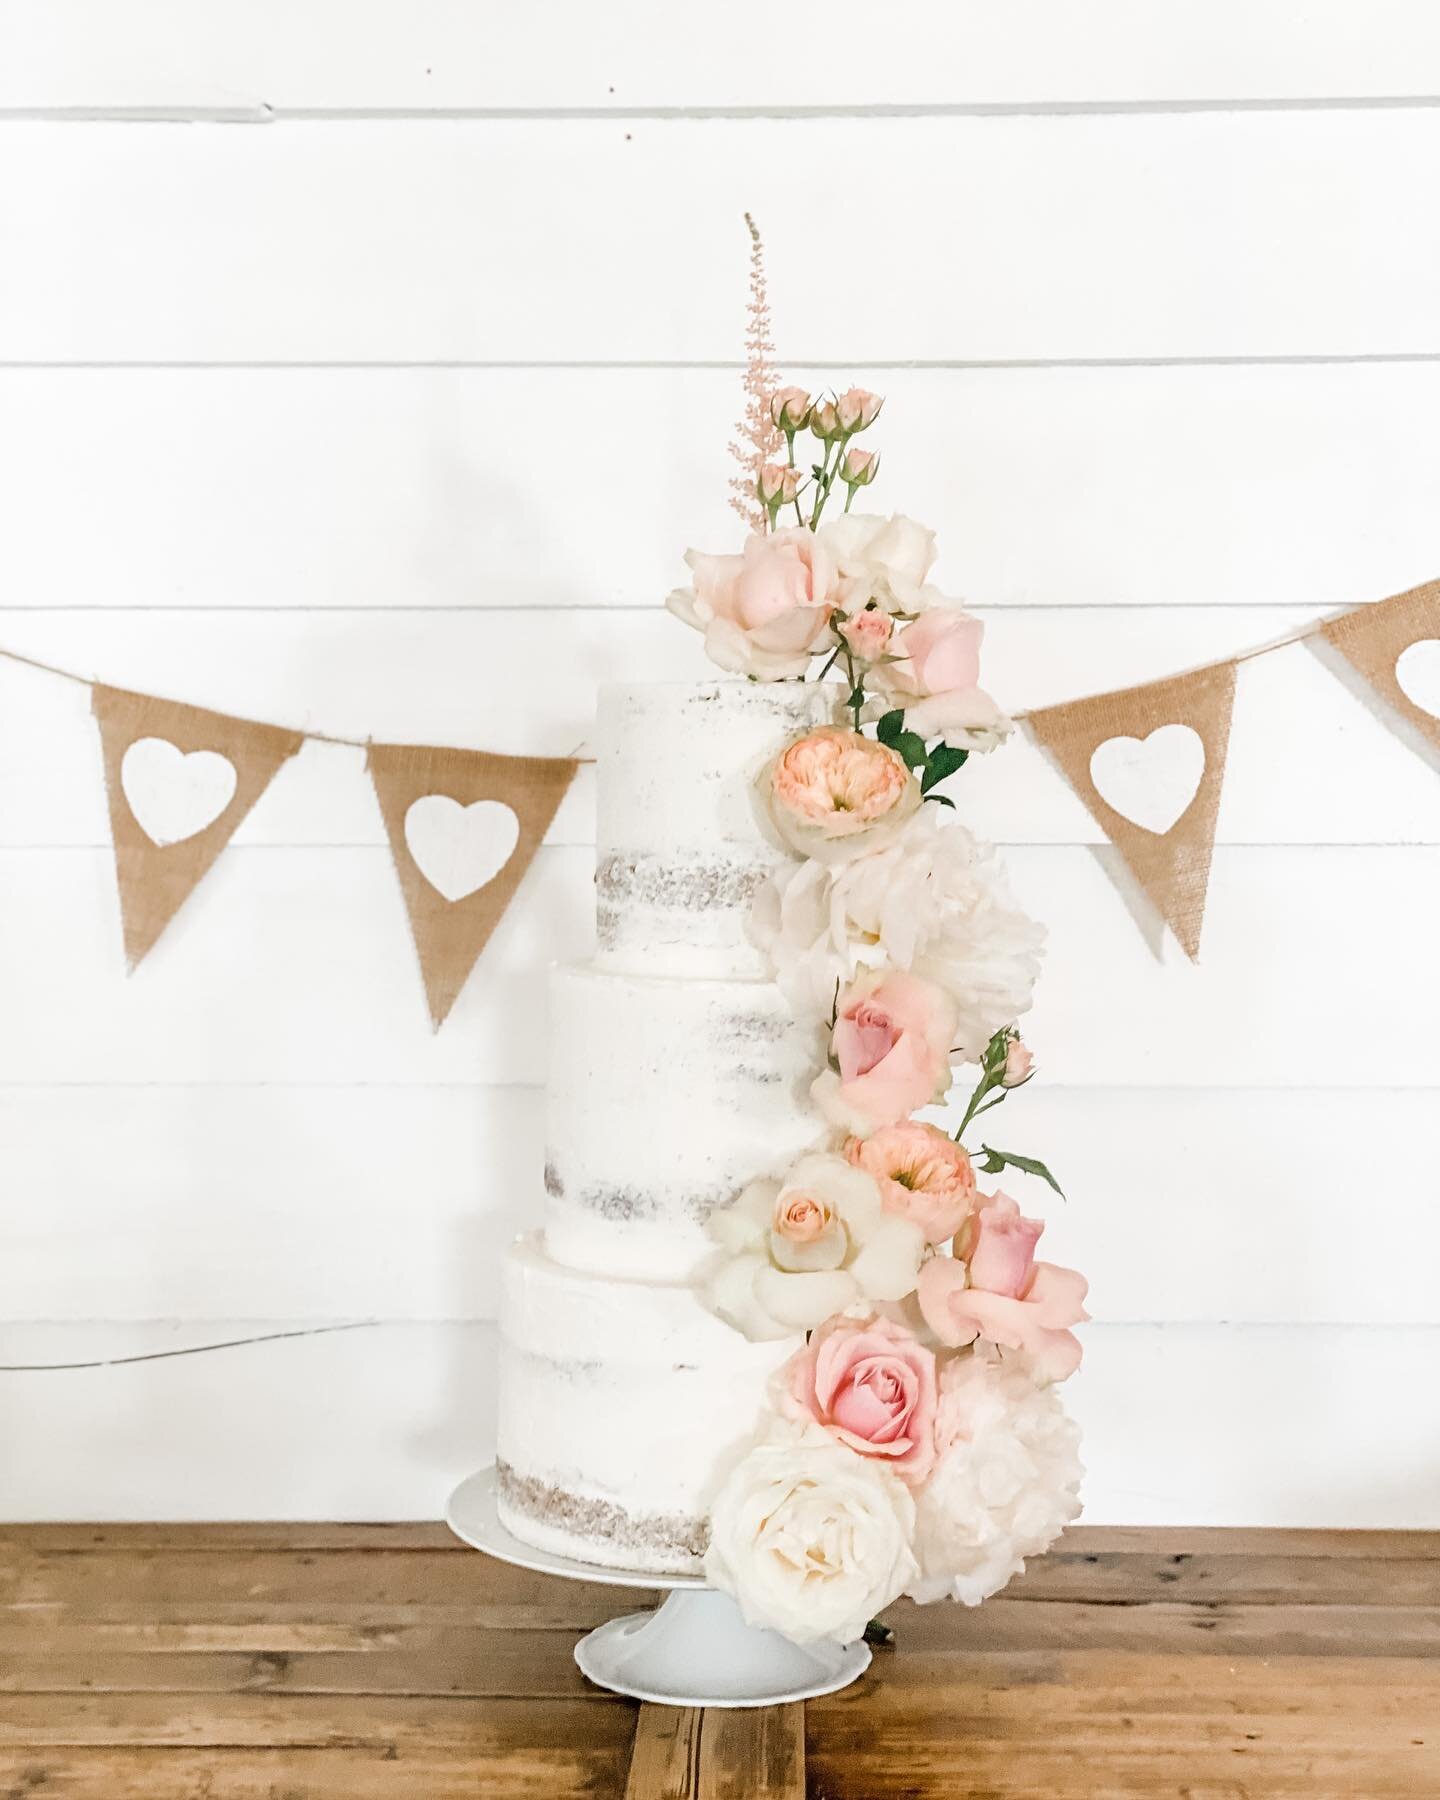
[445,1467,869,1706]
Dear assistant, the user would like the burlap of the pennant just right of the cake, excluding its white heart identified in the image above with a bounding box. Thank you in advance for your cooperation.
[1028,662,1235,961]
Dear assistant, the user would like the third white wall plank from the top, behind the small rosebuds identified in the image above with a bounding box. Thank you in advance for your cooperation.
[0,365,1440,608]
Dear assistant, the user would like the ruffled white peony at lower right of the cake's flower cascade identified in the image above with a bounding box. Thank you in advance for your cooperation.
[907,1348,1084,1606]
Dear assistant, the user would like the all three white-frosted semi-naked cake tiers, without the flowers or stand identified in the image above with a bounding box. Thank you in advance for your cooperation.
[497,680,841,1573]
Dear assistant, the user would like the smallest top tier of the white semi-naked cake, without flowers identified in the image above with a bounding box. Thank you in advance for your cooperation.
[596,680,839,979]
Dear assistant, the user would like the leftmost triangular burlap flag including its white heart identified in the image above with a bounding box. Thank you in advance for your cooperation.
[90,684,304,968]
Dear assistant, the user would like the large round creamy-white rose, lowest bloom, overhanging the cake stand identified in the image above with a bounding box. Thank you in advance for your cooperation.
[706,1426,916,1643]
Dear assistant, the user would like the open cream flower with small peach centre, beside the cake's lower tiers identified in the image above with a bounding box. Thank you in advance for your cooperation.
[709,1152,925,1343]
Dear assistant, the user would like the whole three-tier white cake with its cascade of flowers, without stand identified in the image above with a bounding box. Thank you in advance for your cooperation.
[497,389,1085,1643]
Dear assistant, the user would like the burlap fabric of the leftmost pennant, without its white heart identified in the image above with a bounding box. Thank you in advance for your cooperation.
[90,684,304,968]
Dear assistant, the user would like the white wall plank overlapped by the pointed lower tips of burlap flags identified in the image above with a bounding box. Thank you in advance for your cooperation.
[0,846,1440,1087]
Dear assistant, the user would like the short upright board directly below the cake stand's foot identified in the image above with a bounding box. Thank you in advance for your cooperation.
[625,1705,805,1800]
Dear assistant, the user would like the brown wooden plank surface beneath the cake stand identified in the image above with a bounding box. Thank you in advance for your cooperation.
[0,1525,1440,1800]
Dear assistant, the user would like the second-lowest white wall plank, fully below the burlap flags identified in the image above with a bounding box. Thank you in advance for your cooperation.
[0,1084,1440,1327]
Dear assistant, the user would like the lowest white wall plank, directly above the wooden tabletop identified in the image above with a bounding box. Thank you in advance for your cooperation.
[0,1321,1440,1526]
